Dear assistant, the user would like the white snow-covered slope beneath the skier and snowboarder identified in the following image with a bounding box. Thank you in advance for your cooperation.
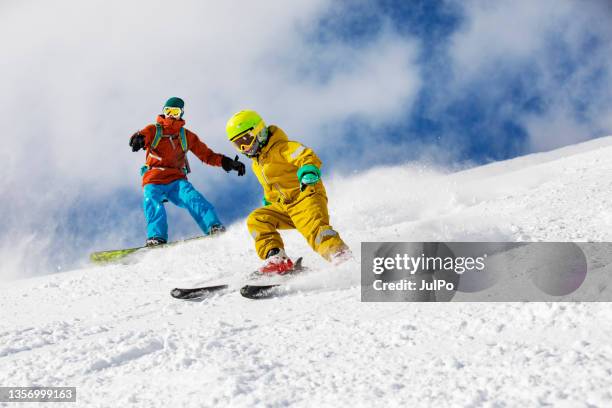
[0,137,612,407]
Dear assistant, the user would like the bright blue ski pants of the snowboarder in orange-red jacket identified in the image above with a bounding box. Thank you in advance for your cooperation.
[143,179,222,241]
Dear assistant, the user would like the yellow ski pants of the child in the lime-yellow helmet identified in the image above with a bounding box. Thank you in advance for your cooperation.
[247,187,347,260]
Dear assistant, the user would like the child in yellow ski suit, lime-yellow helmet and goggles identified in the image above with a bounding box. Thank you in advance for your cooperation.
[226,110,351,274]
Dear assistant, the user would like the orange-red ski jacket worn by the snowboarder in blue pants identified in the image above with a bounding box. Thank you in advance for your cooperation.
[140,115,223,186]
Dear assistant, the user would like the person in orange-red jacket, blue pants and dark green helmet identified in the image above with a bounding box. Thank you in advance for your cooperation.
[130,97,245,246]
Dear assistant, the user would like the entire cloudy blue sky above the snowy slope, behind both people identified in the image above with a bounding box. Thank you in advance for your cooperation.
[0,0,612,277]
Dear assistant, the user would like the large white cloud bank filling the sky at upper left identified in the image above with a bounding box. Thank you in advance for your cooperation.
[0,0,420,274]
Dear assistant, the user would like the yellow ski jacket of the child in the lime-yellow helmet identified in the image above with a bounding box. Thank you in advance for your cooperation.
[251,125,325,204]
